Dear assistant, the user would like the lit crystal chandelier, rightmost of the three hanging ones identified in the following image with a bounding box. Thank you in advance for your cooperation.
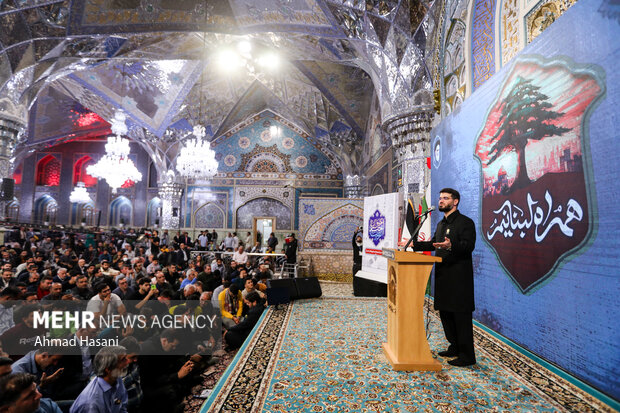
[176,125,218,179]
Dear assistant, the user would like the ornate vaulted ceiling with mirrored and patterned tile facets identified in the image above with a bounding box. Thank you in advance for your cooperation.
[0,0,437,174]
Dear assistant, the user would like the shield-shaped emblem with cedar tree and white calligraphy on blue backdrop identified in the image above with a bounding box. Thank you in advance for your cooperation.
[475,55,603,294]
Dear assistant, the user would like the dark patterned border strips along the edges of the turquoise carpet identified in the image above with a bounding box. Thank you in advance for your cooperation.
[200,296,615,413]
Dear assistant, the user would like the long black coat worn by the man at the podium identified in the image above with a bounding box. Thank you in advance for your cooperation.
[414,210,476,312]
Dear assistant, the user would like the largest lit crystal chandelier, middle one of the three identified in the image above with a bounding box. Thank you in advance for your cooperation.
[86,110,142,194]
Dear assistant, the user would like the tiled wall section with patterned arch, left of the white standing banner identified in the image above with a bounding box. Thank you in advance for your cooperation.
[298,198,364,250]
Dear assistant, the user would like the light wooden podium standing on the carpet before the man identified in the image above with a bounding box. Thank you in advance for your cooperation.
[383,249,441,371]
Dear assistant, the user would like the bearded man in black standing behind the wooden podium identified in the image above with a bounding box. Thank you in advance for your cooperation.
[413,188,476,366]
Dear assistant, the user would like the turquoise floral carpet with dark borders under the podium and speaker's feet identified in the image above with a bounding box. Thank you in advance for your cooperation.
[195,283,612,412]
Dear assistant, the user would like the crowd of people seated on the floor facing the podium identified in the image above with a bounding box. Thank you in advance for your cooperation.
[0,227,297,413]
